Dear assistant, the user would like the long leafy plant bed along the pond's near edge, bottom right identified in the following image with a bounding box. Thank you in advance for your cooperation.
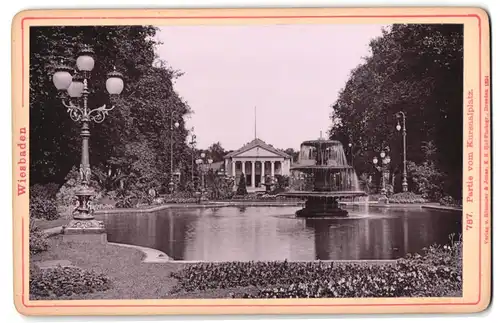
[173,241,462,298]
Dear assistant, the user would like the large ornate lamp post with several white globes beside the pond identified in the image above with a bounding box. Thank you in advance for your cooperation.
[52,45,124,233]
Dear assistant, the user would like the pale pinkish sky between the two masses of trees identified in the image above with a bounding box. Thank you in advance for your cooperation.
[156,24,383,150]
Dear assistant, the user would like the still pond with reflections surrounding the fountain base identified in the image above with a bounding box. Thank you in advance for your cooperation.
[105,206,462,261]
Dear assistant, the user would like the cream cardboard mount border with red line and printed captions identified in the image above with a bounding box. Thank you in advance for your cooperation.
[12,7,491,315]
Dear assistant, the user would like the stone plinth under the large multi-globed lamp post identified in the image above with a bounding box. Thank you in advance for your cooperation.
[63,219,107,243]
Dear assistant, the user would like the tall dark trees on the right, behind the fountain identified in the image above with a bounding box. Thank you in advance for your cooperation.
[330,24,463,200]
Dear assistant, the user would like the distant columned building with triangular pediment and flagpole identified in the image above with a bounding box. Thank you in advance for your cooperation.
[224,138,292,189]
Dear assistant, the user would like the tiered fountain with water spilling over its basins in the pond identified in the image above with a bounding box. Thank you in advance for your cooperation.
[280,138,366,217]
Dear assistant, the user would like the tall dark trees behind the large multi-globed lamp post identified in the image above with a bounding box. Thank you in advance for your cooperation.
[30,26,191,201]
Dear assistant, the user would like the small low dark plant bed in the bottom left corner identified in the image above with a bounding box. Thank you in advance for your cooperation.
[29,266,110,299]
